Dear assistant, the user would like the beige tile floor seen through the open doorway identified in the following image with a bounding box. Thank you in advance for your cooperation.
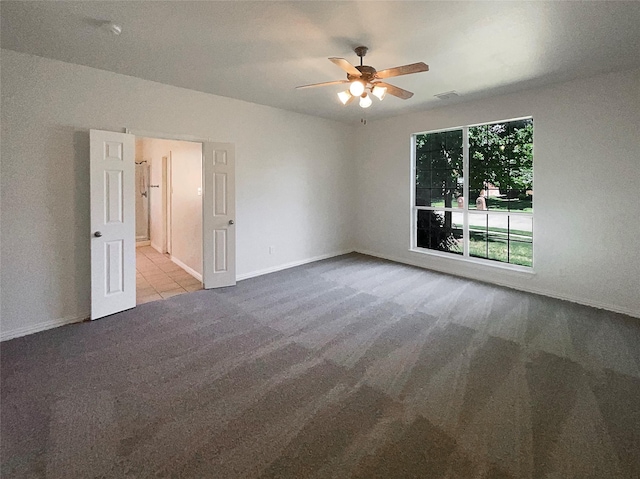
[136,246,202,304]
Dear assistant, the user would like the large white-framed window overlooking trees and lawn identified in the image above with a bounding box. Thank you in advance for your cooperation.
[412,118,533,267]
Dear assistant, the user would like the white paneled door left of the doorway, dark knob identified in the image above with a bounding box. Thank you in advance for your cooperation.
[89,130,136,319]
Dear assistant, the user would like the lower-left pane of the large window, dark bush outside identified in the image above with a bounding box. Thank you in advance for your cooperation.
[416,210,464,254]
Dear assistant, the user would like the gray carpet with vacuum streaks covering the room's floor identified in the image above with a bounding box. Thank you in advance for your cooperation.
[1,254,640,479]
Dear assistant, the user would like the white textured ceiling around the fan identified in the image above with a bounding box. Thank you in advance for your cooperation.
[0,0,640,122]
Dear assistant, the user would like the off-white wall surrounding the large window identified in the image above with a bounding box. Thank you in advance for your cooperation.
[356,66,640,317]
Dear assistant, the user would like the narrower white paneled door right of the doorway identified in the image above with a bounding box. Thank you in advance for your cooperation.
[202,142,236,289]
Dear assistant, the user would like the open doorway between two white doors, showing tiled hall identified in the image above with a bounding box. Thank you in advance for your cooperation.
[136,137,202,304]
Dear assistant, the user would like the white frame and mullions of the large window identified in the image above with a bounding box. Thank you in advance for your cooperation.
[409,115,535,274]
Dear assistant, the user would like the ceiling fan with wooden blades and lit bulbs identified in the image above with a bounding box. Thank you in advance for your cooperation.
[296,46,429,108]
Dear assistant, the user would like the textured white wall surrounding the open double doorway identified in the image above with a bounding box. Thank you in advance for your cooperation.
[0,50,353,338]
